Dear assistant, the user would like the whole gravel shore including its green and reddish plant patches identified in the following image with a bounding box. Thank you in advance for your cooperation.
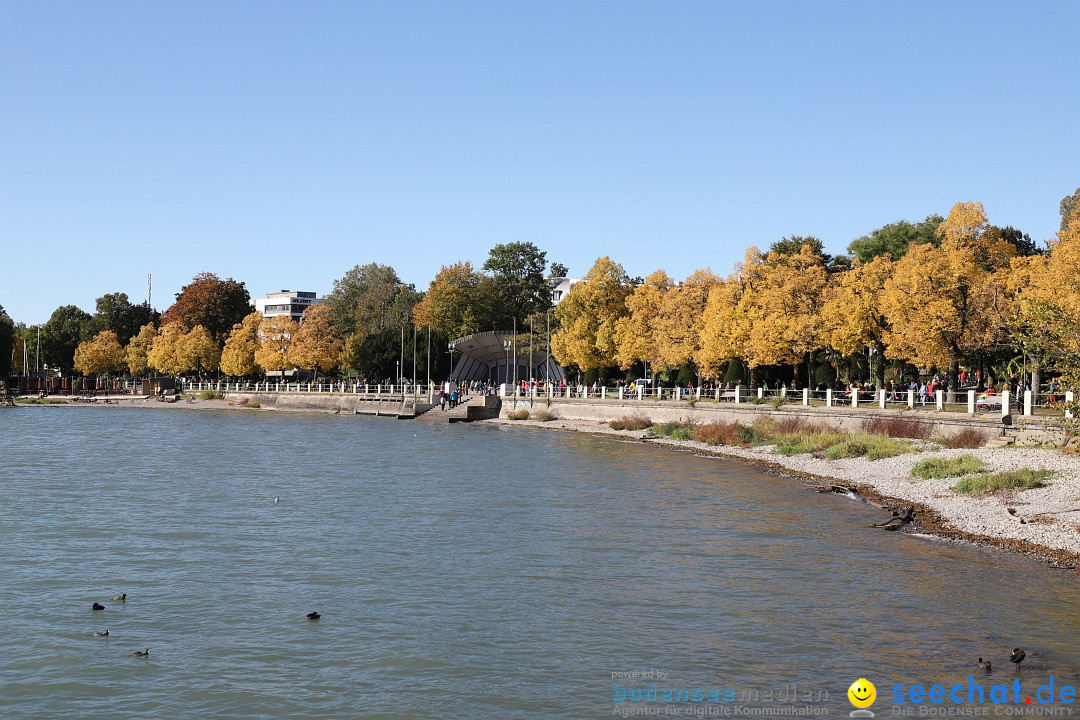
[494,415,1080,573]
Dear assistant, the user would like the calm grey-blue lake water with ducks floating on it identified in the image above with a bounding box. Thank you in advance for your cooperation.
[0,407,1080,720]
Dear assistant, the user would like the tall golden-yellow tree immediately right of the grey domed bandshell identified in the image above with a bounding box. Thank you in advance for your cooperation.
[551,256,630,370]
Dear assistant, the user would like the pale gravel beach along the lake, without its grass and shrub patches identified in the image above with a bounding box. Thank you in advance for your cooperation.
[485,418,1080,568]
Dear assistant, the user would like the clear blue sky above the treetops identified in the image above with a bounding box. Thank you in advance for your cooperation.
[0,0,1080,324]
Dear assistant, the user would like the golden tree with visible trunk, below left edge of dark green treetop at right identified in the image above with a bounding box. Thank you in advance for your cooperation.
[821,255,893,390]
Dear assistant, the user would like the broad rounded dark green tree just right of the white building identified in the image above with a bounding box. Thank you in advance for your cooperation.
[321,262,420,341]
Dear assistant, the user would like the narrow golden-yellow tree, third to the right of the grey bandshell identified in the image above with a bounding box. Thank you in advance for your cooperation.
[656,268,719,367]
